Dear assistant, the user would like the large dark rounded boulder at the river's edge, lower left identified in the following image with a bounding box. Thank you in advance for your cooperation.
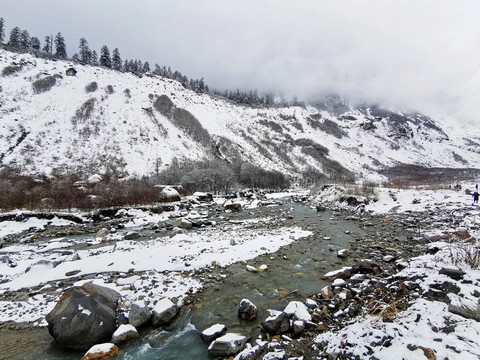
[46,283,121,350]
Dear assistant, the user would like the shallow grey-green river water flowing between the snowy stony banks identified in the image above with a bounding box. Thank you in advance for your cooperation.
[0,201,368,360]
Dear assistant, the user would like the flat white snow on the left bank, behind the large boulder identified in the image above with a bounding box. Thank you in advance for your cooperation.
[0,197,310,326]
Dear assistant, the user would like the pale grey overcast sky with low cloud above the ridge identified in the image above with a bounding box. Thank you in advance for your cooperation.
[0,0,480,123]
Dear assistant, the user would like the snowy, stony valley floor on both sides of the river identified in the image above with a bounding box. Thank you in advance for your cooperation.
[0,184,480,359]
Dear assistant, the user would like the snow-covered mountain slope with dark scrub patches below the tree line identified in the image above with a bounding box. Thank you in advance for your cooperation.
[0,50,480,179]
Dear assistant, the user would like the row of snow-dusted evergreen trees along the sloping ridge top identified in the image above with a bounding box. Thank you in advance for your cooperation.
[0,17,305,108]
